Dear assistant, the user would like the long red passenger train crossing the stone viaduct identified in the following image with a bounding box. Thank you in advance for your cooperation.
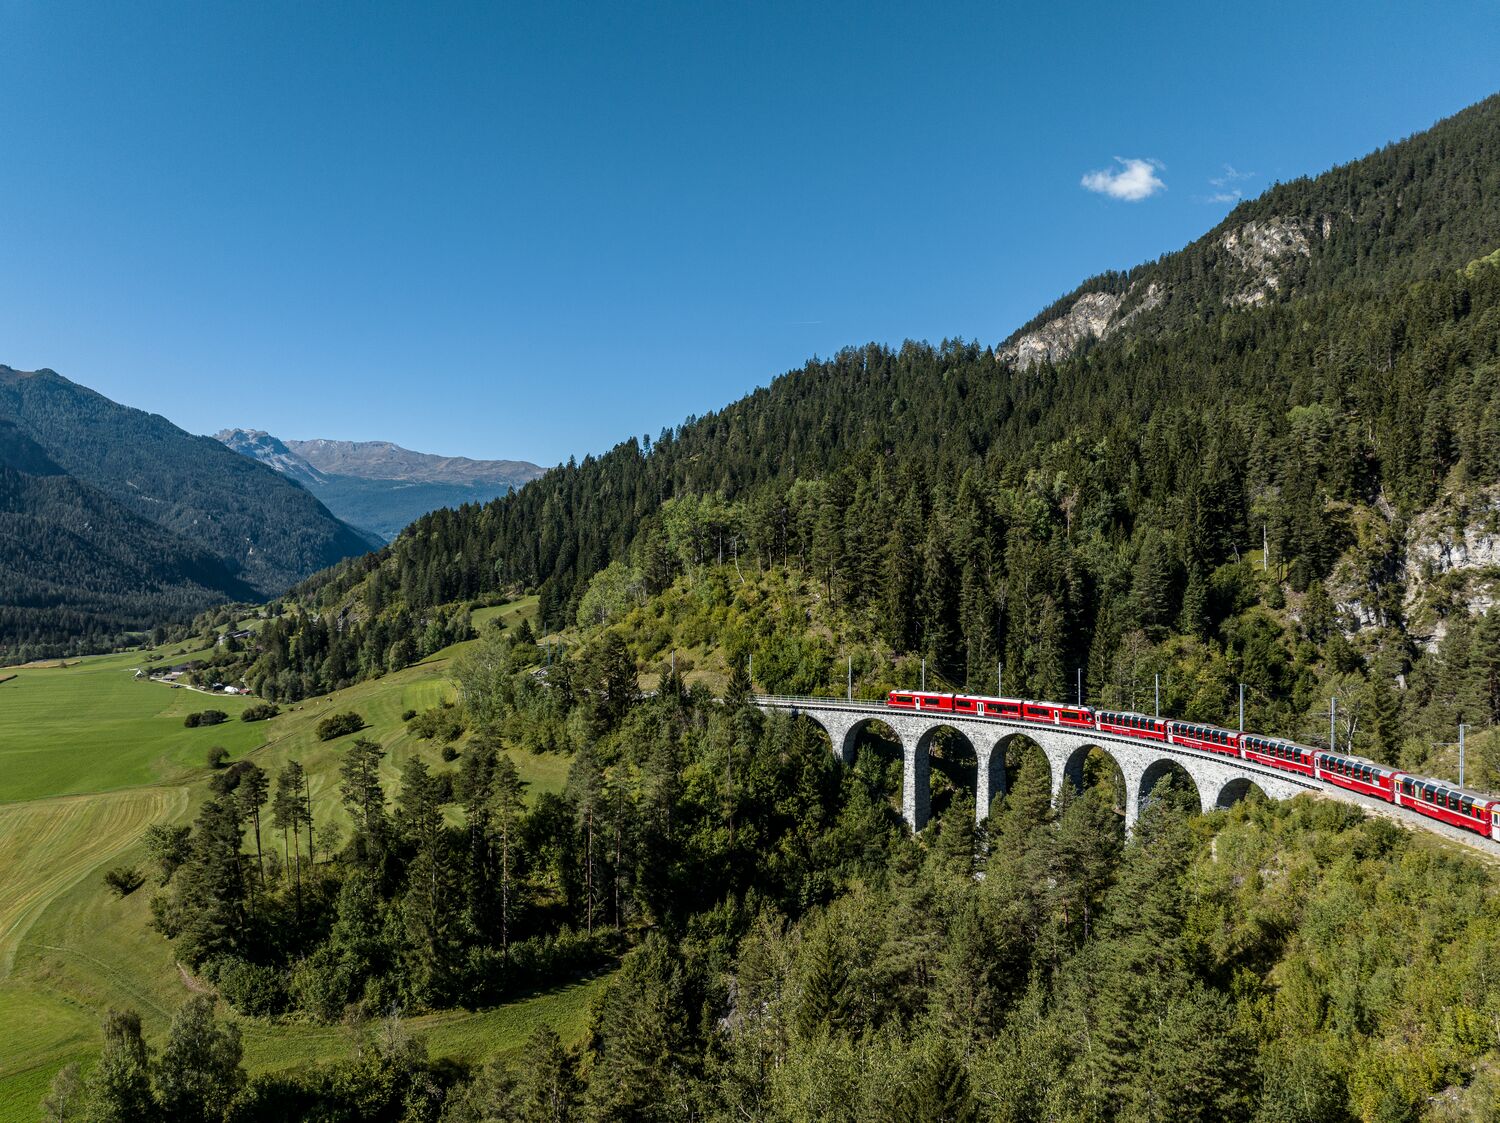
[887,690,1500,841]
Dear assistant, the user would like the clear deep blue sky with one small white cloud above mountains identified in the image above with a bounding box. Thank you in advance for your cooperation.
[0,0,1500,463]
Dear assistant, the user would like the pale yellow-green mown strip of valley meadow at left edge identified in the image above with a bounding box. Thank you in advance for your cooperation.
[0,787,188,981]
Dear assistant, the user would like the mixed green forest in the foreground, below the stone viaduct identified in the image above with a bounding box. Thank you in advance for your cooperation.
[58,628,1500,1123]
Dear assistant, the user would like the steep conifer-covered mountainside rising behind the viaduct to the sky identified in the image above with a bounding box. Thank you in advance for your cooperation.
[273,99,1500,743]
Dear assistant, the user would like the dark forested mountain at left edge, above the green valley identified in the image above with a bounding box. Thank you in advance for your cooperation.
[0,366,378,655]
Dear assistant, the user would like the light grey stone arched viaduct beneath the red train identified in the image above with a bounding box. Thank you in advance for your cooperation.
[755,697,1362,843]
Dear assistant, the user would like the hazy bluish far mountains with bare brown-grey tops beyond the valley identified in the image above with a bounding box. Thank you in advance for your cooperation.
[215,429,542,541]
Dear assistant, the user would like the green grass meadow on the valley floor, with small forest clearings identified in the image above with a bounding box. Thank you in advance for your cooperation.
[0,598,603,1123]
